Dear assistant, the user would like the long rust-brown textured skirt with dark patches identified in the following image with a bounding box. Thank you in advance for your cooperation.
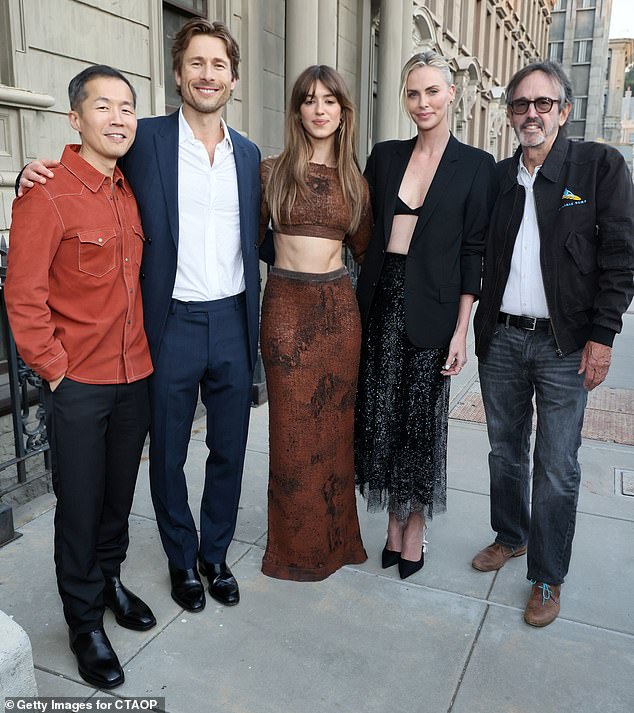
[261,268,367,582]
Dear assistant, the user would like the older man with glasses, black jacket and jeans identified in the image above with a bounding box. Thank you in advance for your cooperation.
[472,62,634,626]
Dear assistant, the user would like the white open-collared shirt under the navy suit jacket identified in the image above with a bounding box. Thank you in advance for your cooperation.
[172,107,245,302]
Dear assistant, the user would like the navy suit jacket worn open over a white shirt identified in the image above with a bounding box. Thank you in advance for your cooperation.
[119,112,260,368]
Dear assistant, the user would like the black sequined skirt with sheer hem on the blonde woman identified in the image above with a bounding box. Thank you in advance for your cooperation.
[355,253,449,520]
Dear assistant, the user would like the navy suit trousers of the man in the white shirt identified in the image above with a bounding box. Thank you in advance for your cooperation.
[150,293,253,569]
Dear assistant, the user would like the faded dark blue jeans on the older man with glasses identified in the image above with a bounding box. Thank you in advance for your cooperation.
[479,324,587,584]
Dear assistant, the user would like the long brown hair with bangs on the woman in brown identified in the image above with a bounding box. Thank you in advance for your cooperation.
[266,64,365,234]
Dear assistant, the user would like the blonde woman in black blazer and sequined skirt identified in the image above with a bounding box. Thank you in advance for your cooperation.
[355,51,497,579]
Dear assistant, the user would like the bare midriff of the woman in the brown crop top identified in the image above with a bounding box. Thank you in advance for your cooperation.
[274,233,343,274]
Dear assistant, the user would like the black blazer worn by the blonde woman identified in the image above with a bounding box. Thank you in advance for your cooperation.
[357,136,497,349]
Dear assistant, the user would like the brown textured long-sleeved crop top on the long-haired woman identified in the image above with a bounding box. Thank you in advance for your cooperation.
[260,157,372,262]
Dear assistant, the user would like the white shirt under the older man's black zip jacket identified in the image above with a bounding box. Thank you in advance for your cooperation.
[500,155,550,318]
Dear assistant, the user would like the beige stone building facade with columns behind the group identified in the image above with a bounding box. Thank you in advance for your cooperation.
[0,0,552,400]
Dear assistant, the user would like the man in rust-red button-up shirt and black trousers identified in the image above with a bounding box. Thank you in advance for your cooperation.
[5,65,156,688]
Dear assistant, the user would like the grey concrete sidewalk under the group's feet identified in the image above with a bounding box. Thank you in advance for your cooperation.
[0,313,634,713]
